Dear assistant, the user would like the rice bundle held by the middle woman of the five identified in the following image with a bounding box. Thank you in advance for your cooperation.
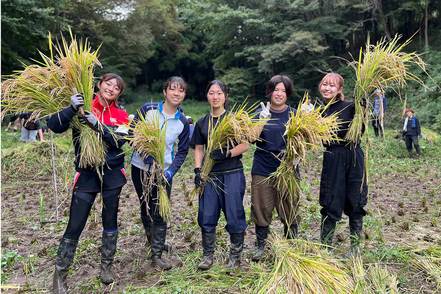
[191,102,268,196]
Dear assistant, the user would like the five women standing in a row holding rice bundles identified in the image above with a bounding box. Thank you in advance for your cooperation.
[48,73,367,293]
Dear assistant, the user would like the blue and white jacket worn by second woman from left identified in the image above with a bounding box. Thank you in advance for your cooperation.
[131,102,190,174]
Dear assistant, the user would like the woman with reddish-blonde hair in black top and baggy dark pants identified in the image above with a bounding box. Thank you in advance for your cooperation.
[319,73,368,252]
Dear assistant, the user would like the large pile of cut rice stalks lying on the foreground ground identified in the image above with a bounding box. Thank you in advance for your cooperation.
[254,236,353,294]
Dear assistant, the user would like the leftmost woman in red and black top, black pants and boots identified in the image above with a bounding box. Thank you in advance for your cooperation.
[48,73,128,293]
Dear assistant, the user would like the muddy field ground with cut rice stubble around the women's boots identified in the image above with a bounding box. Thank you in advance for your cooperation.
[1,112,441,293]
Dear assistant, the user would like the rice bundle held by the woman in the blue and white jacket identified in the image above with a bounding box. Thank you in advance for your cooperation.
[127,113,171,221]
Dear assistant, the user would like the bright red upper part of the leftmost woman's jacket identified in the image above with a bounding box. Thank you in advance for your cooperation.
[92,95,129,127]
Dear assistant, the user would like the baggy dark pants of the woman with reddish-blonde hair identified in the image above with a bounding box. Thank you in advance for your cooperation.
[320,146,368,222]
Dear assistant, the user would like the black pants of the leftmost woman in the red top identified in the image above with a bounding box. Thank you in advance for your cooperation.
[63,187,122,240]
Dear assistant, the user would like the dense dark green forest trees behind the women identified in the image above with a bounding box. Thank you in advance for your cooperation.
[1,0,441,131]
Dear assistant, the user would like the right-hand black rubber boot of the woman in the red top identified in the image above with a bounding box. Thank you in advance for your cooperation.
[100,232,118,285]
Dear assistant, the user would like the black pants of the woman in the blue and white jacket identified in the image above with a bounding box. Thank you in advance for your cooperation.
[132,165,171,227]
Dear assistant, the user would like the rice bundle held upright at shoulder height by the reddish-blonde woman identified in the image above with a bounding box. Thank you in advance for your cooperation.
[346,36,425,143]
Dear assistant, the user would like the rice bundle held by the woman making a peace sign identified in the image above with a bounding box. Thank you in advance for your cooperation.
[267,93,339,224]
